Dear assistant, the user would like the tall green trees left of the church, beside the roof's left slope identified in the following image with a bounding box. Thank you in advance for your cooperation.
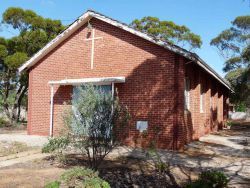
[0,7,65,122]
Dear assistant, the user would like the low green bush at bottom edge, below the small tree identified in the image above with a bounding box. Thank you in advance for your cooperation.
[46,167,110,188]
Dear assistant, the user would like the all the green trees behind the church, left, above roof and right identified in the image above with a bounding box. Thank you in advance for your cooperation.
[0,7,247,122]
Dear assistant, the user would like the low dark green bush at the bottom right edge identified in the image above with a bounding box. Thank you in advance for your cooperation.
[186,171,229,188]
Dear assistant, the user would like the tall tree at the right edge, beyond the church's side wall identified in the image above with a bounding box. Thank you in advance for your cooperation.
[210,15,250,108]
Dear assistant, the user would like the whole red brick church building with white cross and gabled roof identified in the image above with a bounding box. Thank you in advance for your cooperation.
[19,11,230,148]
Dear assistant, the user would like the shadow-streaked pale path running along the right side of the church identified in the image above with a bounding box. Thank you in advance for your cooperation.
[109,126,250,188]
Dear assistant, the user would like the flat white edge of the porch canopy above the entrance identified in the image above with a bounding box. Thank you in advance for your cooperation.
[49,77,125,85]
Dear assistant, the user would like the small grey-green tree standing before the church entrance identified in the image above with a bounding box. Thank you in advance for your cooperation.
[43,85,129,169]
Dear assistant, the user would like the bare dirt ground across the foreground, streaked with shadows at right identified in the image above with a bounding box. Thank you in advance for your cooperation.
[0,122,250,188]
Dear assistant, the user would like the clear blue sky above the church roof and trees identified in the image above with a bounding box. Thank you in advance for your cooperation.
[0,0,250,75]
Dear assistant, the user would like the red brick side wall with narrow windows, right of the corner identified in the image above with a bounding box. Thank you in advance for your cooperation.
[185,63,229,140]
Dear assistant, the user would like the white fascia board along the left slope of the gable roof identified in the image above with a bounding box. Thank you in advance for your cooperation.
[18,12,90,73]
